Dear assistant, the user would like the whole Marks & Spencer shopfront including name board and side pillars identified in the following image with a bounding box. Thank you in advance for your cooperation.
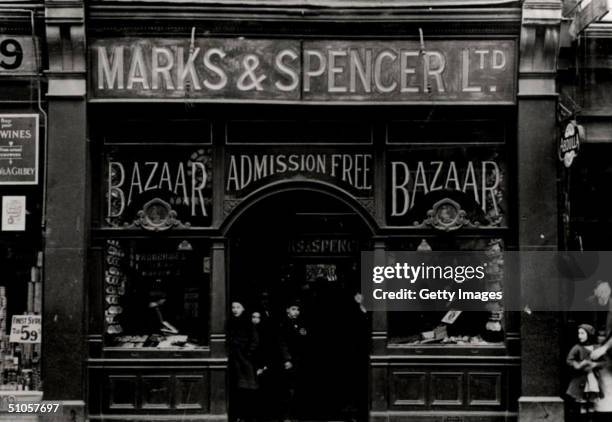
[1,1,562,421]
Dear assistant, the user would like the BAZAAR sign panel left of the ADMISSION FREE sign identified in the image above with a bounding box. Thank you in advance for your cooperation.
[102,145,212,231]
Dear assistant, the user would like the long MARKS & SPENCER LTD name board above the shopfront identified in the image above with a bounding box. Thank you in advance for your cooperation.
[89,38,516,104]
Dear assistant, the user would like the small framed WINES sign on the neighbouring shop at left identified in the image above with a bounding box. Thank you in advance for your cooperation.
[0,114,39,185]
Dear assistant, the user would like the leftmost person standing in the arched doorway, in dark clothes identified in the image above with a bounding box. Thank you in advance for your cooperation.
[227,301,259,422]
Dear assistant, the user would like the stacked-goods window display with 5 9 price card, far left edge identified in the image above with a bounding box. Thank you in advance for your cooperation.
[0,244,42,391]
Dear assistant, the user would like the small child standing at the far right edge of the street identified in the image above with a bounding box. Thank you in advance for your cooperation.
[566,324,601,421]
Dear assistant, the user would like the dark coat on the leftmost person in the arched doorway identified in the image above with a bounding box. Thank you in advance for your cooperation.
[227,313,259,390]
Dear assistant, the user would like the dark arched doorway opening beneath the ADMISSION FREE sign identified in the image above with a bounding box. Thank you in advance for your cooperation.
[228,189,372,420]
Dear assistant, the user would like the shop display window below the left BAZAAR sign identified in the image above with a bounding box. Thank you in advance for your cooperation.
[104,239,210,350]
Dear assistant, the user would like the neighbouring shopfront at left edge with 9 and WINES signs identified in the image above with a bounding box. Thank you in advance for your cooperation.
[0,7,46,420]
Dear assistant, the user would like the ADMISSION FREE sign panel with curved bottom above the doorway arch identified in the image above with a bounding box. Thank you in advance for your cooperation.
[225,147,374,198]
